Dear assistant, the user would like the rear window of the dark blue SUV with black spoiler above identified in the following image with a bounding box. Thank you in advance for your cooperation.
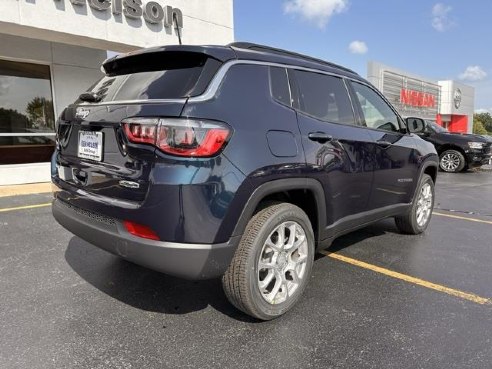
[83,52,221,102]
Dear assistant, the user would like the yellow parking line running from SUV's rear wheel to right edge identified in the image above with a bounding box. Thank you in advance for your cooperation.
[321,251,492,305]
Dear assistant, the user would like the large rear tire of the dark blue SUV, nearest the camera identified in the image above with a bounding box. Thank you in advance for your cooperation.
[222,203,315,320]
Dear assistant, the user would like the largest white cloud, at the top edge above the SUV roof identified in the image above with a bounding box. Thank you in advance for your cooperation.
[284,0,349,28]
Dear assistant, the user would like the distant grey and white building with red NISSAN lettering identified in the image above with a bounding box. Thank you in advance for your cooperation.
[367,61,475,133]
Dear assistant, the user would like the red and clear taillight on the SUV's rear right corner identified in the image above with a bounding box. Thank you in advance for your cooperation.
[122,118,231,157]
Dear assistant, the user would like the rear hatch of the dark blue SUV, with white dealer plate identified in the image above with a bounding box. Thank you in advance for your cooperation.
[57,47,233,207]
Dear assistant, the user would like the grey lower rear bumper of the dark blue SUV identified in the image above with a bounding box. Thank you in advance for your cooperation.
[53,199,240,280]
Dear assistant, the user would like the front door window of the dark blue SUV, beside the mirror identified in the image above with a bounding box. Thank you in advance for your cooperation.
[352,82,400,131]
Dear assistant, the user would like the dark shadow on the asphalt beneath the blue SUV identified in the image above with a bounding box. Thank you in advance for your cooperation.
[65,218,392,323]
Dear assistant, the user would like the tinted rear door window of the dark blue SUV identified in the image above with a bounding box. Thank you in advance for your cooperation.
[294,70,355,124]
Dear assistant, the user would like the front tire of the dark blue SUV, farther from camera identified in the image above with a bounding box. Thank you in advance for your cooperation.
[395,174,435,234]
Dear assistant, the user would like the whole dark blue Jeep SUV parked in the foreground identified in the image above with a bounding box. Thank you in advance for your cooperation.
[53,43,438,320]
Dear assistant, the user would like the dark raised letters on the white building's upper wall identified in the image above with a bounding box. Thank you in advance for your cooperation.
[54,0,183,28]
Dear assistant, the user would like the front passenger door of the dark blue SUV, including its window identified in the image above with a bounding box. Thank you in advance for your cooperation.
[350,81,419,210]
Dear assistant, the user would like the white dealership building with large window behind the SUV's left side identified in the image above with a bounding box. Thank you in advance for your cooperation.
[0,0,234,185]
